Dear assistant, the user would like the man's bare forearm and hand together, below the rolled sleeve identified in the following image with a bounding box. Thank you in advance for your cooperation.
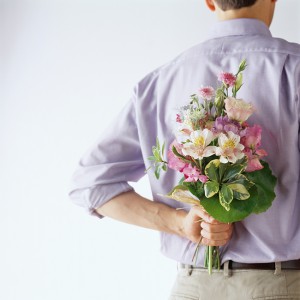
[96,191,232,246]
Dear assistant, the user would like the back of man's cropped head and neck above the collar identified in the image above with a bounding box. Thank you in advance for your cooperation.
[206,0,277,26]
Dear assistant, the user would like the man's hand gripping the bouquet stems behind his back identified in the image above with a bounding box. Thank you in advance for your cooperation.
[182,206,233,246]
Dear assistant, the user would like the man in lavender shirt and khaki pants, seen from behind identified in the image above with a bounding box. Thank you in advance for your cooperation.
[70,0,300,300]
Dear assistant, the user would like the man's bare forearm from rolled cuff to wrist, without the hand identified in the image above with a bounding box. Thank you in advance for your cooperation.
[97,191,187,236]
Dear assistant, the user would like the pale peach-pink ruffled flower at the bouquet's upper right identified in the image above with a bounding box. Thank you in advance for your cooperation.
[224,97,254,123]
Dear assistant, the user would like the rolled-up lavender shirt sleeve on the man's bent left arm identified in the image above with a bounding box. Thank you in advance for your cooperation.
[69,89,145,218]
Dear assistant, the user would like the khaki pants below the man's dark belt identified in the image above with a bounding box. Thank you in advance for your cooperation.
[169,263,300,300]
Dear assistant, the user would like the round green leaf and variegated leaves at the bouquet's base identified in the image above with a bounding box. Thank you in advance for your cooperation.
[183,159,276,223]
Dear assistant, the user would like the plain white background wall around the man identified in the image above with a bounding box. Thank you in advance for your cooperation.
[0,0,300,300]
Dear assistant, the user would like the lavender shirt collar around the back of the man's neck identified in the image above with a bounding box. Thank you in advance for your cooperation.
[208,19,272,39]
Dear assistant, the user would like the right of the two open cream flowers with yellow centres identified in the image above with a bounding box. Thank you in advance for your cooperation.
[216,131,245,164]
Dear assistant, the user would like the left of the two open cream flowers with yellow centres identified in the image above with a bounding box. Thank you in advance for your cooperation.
[182,128,216,159]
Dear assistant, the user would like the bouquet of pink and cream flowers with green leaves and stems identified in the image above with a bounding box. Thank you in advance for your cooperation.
[149,60,276,273]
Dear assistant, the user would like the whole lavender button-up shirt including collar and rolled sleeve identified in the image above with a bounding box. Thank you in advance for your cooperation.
[70,19,300,265]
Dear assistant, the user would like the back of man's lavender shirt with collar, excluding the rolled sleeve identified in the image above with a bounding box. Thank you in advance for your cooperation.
[134,19,300,264]
